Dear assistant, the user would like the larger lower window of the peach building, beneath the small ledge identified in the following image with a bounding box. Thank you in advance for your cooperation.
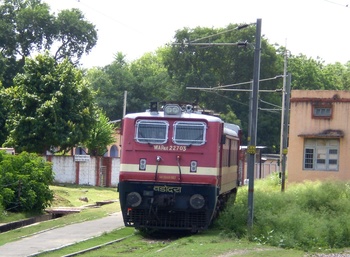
[303,138,339,171]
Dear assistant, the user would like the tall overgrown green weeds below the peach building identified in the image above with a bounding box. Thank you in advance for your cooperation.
[218,176,350,251]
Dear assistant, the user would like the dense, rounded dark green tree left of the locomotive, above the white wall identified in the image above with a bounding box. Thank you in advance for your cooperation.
[5,53,96,154]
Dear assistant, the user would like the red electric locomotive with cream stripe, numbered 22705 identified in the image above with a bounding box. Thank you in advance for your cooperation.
[118,103,240,231]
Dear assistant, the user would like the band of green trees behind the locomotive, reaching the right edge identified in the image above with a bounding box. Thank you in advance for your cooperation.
[88,24,350,153]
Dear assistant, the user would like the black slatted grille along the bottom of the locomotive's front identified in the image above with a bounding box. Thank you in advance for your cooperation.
[126,209,209,229]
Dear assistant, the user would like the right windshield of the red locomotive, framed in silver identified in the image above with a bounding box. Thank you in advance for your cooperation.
[173,121,207,145]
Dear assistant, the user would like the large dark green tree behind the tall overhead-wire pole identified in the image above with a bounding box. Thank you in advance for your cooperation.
[164,24,283,149]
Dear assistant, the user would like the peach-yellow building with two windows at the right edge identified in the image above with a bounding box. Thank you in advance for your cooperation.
[287,90,350,183]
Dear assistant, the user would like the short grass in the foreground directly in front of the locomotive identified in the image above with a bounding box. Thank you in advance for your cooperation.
[34,225,305,257]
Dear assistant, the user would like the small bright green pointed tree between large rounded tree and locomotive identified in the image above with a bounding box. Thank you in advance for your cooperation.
[84,110,115,156]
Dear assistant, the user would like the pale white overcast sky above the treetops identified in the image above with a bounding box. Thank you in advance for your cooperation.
[42,0,350,68]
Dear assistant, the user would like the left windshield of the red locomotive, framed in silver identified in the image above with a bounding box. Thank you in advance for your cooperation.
[135,120,169,144]
